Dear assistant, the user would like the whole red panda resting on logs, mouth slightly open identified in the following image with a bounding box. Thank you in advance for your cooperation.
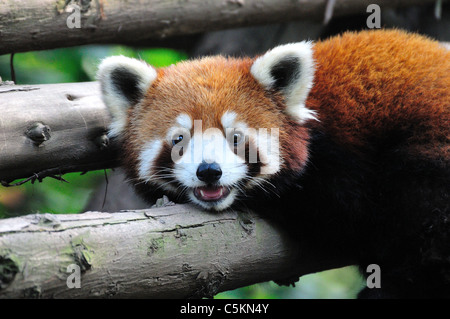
[98,30,450,298]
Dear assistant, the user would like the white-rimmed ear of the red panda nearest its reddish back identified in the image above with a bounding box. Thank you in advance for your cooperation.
[250,41,317,123]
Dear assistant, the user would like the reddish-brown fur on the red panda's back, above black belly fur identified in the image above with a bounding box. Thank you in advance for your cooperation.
[307,30,450,161]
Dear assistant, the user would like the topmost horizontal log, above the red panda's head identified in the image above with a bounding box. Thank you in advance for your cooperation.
[0,0,445,54]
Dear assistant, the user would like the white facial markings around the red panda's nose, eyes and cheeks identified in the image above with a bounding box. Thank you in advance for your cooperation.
[139,112,280,211]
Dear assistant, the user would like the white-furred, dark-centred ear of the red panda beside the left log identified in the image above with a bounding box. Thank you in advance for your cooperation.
[97,56,156,137]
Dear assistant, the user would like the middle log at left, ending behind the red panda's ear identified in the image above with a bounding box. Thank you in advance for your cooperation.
[0,82,117,182]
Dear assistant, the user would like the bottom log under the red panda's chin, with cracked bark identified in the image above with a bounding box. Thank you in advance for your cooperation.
[0,205,342,298]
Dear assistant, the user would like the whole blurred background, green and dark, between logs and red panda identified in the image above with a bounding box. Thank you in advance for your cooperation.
[0,1,450,298]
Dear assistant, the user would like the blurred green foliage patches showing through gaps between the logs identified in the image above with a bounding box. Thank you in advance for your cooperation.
[0,46,363,298]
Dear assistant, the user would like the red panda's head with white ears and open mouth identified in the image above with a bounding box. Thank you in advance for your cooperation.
[98,42,315,210]
